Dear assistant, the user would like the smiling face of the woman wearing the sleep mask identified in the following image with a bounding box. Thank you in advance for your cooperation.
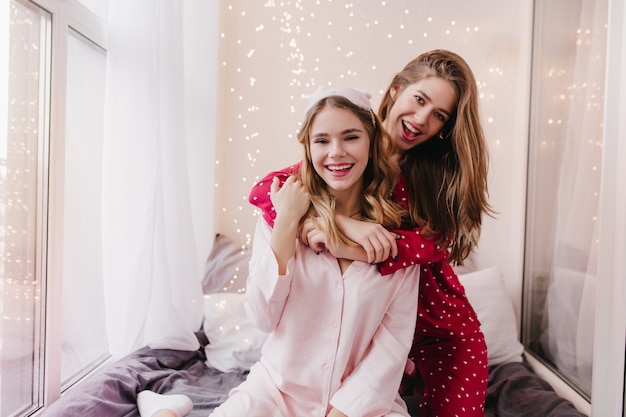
[309,106,370,197]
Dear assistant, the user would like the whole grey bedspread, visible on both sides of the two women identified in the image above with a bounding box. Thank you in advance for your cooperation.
[43,340,584,417]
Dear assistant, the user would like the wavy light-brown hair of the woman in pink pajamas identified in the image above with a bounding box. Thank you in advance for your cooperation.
[298,96,406,244]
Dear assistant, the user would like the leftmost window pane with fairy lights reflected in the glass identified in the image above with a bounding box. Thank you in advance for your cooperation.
[0,1,51,416]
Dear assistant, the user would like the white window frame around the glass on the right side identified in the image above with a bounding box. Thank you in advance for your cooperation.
[522,0,626,416]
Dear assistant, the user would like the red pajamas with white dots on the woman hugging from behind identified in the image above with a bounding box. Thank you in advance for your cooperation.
[249,163,488,417]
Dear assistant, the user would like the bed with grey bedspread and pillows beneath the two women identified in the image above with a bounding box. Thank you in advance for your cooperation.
[43,235,584,417]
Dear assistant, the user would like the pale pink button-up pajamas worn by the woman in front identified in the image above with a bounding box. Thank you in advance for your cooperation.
[212,219,419,417]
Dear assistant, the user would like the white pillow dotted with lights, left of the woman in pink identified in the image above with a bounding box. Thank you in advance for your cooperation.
[203,293,267,372]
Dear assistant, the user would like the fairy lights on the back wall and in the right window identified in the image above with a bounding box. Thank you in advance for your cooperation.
[215,0,602,252]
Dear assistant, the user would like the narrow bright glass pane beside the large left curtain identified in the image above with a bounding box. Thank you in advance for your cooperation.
[61,31,108,387]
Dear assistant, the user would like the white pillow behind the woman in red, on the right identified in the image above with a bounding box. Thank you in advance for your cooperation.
[459,266,524,365]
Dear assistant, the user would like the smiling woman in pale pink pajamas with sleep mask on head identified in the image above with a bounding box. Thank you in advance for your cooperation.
[211,88,419,417]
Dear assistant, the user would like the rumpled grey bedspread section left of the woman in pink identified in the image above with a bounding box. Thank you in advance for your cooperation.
[42,340,245,417]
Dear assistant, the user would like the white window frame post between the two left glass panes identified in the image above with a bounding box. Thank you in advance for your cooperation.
[22,0,108,411]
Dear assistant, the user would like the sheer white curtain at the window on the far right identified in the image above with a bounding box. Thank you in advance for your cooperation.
[543,0,607,393]
